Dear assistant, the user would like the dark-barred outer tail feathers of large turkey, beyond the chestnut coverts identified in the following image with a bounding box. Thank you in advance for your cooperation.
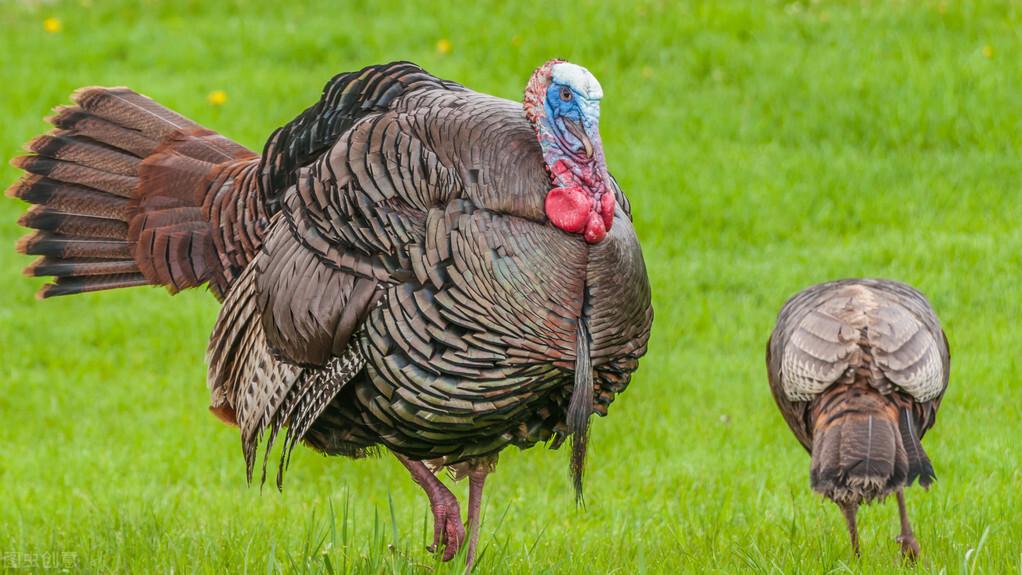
[7,88,158,297]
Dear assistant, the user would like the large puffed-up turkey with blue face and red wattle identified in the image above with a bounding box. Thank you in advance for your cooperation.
[9,60,652,565]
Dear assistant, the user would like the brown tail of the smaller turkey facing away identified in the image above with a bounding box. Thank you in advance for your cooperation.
[810,384,915,505]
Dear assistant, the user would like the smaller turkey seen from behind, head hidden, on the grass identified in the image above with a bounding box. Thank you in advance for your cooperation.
[767,279,950,559]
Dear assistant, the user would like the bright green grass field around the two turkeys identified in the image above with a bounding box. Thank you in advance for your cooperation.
[0,0,1022,575]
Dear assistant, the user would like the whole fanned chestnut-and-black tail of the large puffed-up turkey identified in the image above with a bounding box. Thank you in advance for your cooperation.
[7,88,258,297]
